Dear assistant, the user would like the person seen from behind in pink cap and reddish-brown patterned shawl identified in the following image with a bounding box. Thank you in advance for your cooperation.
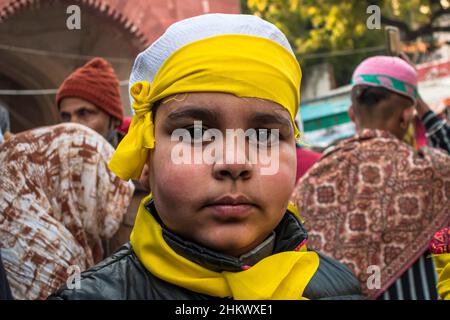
[293,56,450,299]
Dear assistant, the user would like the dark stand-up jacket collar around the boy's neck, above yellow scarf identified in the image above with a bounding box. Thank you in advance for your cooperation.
[145,199,308,272]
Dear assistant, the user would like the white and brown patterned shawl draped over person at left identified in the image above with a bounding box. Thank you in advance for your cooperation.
[0,124,134,299]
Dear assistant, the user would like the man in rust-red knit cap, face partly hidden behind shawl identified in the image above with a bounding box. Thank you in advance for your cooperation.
[56,58,123,147]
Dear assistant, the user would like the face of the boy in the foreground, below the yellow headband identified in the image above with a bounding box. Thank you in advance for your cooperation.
[149,93,296,256]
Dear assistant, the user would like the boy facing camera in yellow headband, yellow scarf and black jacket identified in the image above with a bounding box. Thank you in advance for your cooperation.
[50,14,361,299]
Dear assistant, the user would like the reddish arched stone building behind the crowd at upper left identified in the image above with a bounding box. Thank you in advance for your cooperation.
[0,0,239,132]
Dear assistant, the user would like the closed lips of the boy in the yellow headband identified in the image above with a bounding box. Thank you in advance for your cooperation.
[205,195,257,220]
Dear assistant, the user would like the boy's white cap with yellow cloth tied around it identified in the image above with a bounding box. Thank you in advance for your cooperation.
[109,14,302,180]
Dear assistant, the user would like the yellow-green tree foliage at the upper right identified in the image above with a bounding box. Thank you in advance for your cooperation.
[241,0,448,86]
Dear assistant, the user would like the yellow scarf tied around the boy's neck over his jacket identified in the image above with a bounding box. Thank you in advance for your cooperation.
[131,195,319,300]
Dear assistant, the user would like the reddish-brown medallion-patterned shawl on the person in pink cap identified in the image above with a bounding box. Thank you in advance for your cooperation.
[292,130,450,298]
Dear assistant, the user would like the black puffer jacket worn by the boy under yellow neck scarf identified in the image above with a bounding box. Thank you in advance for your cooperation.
[49,203,363,300]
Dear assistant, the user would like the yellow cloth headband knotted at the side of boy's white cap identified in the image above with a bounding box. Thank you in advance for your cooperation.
[109,35,302,180]
